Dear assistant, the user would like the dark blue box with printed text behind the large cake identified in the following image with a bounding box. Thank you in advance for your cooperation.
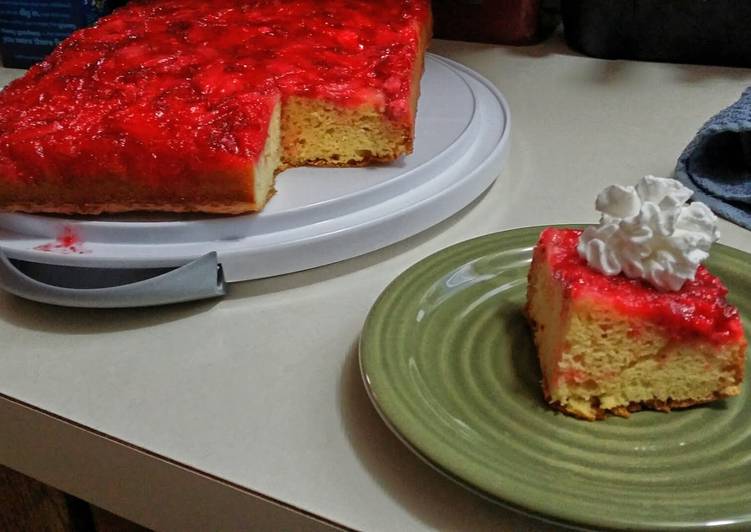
[0,0,124,68]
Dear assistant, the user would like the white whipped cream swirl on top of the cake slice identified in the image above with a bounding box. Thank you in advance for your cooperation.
[577,175,720,291]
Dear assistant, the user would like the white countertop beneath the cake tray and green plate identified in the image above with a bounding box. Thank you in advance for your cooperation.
[0,37,751,530]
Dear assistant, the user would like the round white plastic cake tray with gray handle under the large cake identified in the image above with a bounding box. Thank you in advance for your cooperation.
[0,54,510,307]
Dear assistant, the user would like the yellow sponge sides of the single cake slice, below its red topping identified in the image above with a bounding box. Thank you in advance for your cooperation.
[525,228,747,420]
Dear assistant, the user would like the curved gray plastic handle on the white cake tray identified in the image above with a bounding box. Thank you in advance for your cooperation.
[0,250,227,308]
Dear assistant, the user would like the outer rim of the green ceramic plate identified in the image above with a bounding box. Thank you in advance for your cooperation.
[358,223,751,530]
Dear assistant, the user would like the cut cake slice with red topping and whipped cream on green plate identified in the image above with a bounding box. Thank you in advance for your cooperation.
[526,176,747,420]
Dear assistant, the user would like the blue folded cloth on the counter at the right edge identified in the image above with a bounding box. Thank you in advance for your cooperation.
[675,87,751,229]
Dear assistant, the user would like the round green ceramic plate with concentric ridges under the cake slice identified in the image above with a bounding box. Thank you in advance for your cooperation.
[360,227,751,530]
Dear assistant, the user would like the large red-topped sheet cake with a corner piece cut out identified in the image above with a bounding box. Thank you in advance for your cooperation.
[0,0,431,214]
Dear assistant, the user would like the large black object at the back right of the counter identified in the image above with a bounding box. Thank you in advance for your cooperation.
[562,0,751,66]
